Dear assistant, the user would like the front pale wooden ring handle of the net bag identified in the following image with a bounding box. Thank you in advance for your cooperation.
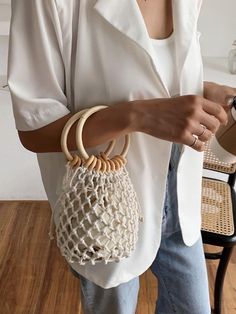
[76,106,130,159]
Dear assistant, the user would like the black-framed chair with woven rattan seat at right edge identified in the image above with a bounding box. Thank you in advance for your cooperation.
[202,142,236,314]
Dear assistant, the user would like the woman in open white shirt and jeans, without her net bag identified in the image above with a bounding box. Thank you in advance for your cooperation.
[8,0,236,314]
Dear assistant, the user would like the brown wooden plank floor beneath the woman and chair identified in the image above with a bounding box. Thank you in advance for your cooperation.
[0,201,236,314]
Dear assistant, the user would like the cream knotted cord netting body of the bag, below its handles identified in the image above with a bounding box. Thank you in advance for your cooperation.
[48,157,143,265]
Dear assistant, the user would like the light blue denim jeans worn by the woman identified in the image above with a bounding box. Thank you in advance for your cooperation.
[71,144,211,314]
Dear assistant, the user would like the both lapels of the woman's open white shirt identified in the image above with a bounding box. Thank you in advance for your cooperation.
[94,0,201,97]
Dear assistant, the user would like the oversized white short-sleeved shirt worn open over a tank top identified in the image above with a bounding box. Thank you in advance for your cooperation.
[8,0,203,288]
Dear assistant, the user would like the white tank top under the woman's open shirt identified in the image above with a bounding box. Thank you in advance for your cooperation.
[150,32,179,96]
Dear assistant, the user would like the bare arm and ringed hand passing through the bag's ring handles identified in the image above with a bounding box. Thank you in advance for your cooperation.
[19,93,229,153]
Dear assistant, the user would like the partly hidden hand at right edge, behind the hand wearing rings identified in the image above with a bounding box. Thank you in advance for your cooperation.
[204,82,236,109]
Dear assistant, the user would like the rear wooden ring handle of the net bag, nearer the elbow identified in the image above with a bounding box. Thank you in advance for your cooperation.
[61,108,115,161]
